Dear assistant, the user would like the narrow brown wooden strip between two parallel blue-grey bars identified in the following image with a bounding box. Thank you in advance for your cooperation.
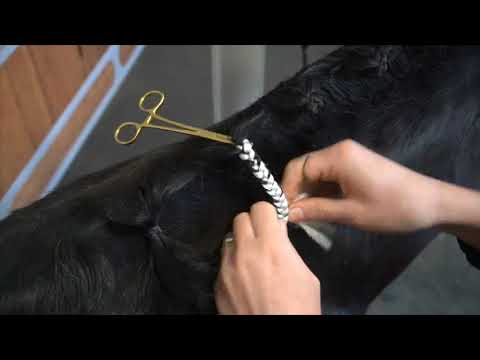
[13,64,114,209]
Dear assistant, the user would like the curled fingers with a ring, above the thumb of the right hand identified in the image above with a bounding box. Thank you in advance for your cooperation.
[282,147,338,202]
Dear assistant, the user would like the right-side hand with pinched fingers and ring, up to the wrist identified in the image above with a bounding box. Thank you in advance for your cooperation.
[282,140,441,233]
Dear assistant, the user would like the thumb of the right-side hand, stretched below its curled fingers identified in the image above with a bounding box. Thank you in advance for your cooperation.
[289,197,354,224]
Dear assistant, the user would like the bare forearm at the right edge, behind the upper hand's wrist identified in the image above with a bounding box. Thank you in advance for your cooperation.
[435,181,480,250]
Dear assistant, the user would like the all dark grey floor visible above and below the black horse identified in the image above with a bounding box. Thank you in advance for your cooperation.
[63,45,480,314]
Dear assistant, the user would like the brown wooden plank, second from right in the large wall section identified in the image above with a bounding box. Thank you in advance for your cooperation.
[27,45,86,119]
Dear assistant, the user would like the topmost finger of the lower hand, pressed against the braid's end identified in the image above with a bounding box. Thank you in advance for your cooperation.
[250,201,280,239]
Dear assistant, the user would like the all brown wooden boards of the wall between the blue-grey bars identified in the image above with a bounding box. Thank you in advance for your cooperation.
[0,45,131,208]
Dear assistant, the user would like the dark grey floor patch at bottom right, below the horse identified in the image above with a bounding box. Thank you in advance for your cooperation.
[368,235,480,315]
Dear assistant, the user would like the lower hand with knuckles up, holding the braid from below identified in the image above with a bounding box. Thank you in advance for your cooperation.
[215,202,321,315]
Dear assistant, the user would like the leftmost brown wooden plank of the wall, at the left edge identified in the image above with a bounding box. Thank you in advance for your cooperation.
[0,67,35,197]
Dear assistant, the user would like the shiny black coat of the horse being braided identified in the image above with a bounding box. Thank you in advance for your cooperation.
[0,46,480,313]
